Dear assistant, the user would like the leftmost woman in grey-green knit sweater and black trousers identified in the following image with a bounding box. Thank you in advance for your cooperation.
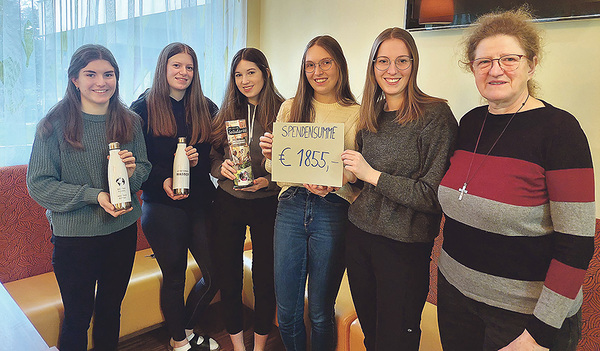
[27,45,151,351]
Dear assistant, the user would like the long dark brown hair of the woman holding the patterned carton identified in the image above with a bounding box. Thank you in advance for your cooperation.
[213,48,284,145]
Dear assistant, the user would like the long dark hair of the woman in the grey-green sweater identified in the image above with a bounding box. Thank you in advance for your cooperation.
[39,44,139,150]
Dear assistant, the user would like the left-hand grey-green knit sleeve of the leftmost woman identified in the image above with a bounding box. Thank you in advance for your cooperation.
[27,128,102,212]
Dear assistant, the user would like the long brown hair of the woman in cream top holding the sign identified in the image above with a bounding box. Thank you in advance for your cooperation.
[289,35,356,122]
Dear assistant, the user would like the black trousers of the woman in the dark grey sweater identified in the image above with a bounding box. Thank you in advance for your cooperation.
[346,223,433,351]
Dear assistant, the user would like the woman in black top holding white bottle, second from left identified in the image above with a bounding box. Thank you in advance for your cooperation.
[131,43,218,351]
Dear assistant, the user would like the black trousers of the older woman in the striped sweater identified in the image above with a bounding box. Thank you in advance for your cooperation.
[438,271,581,351]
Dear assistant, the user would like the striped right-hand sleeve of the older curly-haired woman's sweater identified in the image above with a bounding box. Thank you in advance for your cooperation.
[527,110,596,347]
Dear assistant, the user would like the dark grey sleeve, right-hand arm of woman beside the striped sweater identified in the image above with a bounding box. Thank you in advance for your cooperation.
[375,104,458,213]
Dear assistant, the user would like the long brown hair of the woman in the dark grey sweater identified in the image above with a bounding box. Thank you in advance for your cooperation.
[357,27,446,132]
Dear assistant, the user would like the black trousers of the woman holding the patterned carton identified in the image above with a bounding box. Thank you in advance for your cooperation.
[213,188,277,335]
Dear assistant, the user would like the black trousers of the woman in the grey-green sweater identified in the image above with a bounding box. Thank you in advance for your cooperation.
[52,223,137,351]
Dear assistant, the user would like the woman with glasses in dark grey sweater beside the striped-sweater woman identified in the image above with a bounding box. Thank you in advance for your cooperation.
[342,28,458,351]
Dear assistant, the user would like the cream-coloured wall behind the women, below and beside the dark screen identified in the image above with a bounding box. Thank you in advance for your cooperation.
[256,0,600,217]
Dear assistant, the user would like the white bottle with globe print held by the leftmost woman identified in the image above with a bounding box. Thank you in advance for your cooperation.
[108,141,131,211]
